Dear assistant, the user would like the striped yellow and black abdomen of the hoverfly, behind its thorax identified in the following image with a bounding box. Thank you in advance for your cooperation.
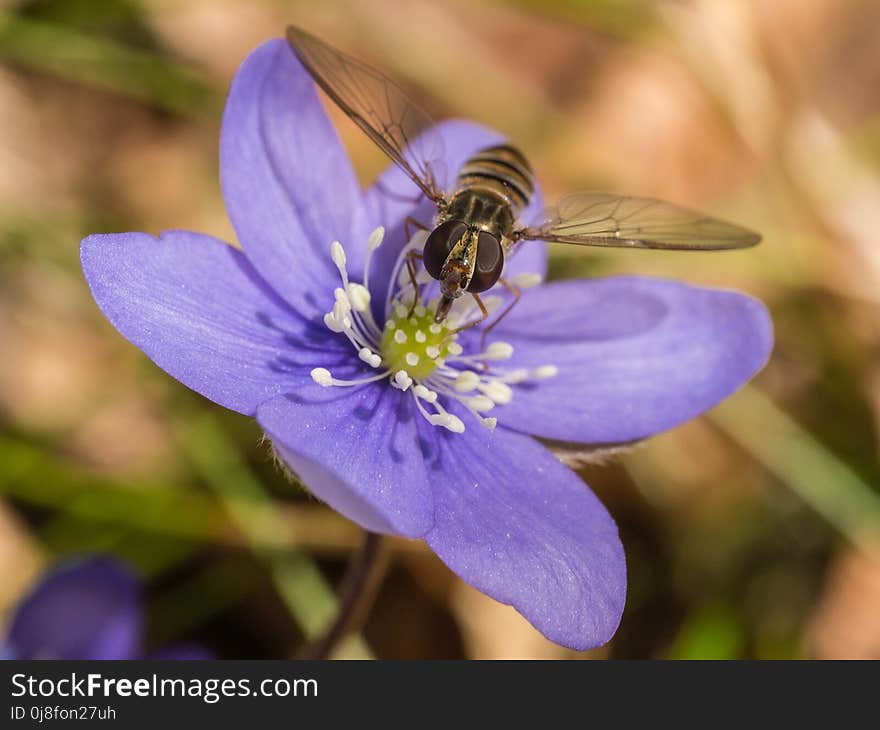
[458,144,535,215]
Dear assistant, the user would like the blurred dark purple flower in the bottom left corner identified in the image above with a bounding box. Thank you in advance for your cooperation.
[9,558,142,659]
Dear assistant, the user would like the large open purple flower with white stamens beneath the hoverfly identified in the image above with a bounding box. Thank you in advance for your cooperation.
[82,40,772,649]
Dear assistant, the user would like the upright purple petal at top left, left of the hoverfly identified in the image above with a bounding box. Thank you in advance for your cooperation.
[220,40,366,317]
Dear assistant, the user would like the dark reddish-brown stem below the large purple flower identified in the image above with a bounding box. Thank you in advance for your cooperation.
[301,532,385,659]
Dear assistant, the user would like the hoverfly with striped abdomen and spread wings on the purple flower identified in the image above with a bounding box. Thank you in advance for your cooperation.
[287,26,761,329]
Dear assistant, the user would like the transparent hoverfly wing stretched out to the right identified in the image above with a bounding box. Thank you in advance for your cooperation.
[514,192,761,251]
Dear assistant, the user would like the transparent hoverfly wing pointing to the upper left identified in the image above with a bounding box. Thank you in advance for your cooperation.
[287,26,444,203]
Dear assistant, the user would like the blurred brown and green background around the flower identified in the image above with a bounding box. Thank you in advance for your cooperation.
[0,0,880,658]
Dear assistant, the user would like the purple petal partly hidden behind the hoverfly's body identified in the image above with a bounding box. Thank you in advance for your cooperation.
[366,119,547,318]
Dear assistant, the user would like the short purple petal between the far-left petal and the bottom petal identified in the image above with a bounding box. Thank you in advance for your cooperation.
[257,382,433,537]
